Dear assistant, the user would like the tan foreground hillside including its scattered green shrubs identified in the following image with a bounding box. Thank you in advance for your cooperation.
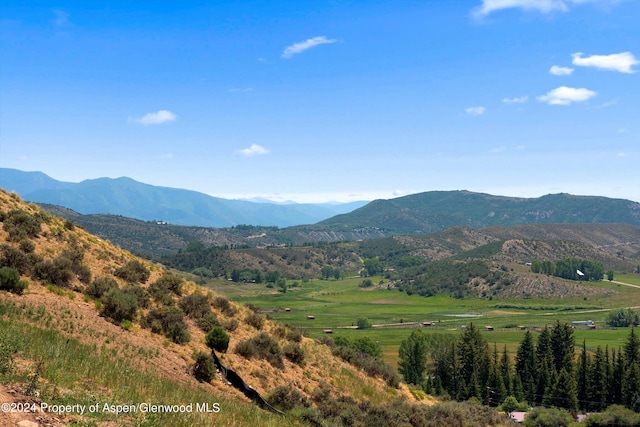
[0,191,442,426]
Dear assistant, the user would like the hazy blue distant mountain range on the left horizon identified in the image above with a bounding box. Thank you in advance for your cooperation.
[0,168,366,227]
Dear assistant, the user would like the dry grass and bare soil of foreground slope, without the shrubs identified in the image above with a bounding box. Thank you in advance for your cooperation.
[0,191,424,426]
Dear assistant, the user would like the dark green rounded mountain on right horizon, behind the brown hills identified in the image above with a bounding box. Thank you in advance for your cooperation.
[314,191,640,235]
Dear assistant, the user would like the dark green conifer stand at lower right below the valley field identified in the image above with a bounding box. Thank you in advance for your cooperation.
[398,321,640,413]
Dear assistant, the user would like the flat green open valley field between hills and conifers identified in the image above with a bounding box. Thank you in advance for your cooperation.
[208,274,640,365]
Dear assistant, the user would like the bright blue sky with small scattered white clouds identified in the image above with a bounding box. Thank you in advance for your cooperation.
[0,0,640,202]
